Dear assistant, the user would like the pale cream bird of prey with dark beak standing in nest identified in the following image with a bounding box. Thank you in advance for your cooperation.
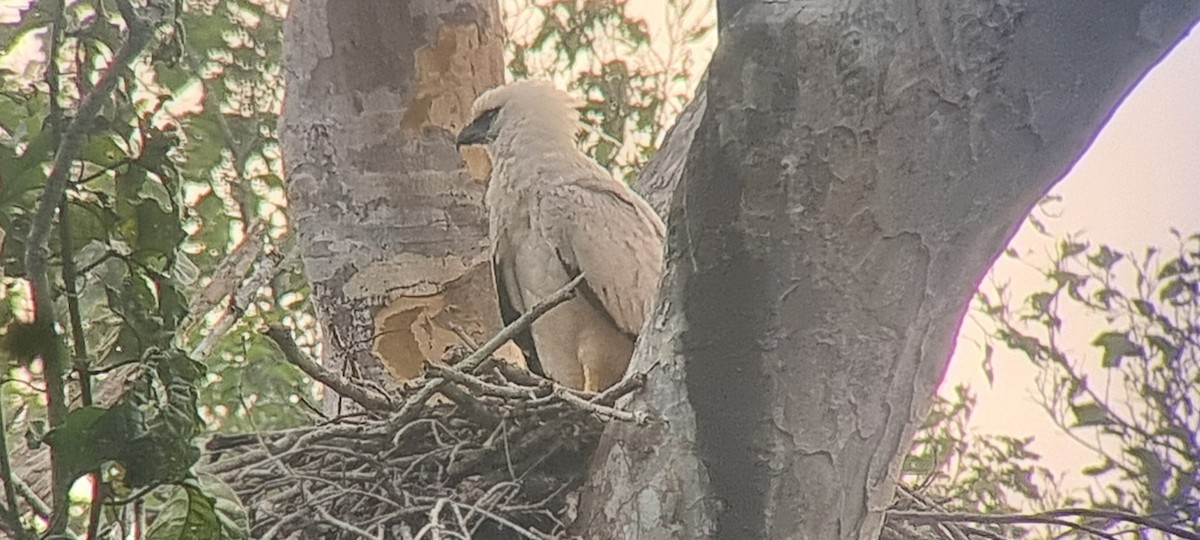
[456,80,666,392]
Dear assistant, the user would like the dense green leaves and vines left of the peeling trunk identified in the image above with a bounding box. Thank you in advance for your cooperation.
[0,0,313,538]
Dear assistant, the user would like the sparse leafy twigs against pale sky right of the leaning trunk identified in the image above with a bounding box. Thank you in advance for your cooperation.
[978,232,1200,530]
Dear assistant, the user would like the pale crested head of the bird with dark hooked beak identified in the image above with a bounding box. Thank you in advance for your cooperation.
[455,80,580,146]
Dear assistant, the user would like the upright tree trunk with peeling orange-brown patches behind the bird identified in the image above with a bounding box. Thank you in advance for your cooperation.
[281,0,504,413]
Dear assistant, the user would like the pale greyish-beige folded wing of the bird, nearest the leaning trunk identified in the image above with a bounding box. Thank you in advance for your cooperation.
[534,179,665,337]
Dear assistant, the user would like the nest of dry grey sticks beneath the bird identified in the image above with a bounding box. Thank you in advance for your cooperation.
[203,278,646,539]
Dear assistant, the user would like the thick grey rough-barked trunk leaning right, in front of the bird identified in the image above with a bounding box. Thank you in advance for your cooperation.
[576,0,1200,540]
